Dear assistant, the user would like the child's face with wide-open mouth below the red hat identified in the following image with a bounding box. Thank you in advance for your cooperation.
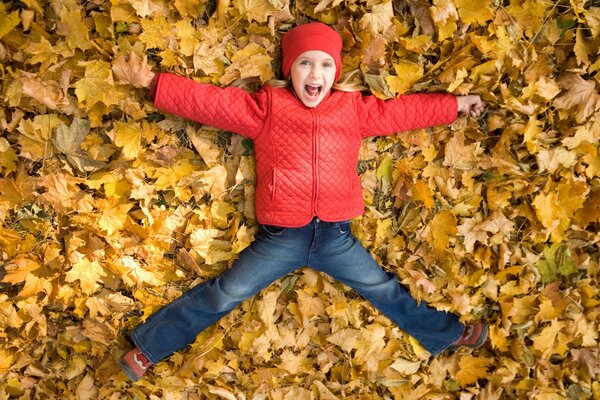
[290,50,336,108]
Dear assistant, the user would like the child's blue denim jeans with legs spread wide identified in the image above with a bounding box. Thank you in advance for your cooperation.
[131,218,464,364]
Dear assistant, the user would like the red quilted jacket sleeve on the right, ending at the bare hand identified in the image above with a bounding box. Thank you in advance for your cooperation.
[358,93,458,137]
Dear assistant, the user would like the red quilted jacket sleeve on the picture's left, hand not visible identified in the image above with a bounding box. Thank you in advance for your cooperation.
[149,73,269,139]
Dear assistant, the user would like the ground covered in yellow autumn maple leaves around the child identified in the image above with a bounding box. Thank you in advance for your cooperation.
[0,0,600,400]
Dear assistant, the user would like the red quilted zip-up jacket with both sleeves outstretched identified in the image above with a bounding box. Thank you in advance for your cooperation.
[153,74,457,227]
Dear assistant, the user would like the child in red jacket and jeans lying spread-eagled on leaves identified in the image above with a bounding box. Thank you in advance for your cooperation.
[120,22,487,380]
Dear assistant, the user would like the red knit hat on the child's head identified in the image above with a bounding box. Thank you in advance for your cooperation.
[281,22,342,81]
